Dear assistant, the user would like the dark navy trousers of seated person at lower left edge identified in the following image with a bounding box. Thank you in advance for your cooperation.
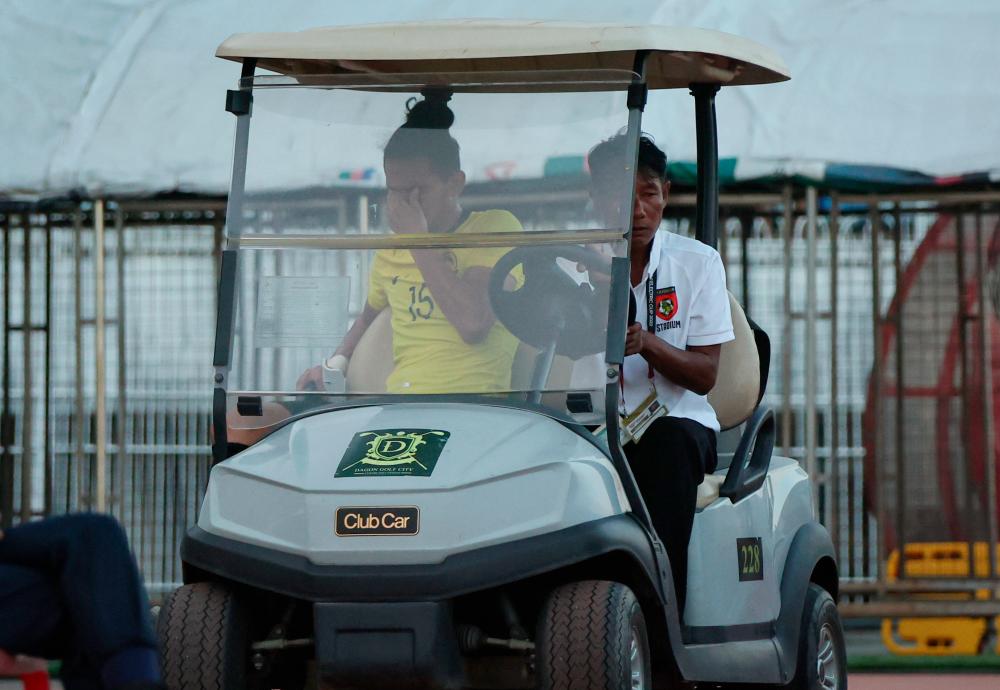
[0,514,156,690]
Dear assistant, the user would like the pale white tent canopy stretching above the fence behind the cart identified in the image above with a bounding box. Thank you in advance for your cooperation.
[0,0,1000,196]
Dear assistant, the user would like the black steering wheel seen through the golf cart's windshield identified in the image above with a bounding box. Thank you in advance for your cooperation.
[489,245,608,359]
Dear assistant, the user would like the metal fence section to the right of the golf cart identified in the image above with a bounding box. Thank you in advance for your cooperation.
[704,189,1000,616]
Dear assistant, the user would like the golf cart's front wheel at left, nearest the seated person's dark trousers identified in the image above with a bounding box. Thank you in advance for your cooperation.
[157,582,248,690]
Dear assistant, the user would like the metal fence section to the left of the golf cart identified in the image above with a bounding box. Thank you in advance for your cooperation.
[0,204,221,591]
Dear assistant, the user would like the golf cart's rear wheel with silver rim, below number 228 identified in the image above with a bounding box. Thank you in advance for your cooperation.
[787,584,847,690]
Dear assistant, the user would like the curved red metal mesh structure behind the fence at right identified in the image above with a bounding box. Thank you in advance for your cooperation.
[863,213,1000,553]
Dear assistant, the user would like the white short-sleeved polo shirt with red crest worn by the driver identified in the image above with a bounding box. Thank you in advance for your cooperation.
[621,229,735,431]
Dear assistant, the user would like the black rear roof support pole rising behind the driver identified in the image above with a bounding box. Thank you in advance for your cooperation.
[691,84,719,247]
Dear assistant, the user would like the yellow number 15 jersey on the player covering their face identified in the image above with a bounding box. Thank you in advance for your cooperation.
[368,210,522,393]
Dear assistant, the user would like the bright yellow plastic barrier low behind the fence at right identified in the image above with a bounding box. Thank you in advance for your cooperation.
[882,542,1000,656]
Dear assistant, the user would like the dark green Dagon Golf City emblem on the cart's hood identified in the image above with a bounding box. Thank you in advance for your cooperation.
[334,429,450,477]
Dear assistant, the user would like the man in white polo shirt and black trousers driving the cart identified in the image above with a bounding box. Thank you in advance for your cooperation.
[588,135,734,614]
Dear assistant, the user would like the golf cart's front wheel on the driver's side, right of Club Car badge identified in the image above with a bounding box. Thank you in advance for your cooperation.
[535,581,652,690]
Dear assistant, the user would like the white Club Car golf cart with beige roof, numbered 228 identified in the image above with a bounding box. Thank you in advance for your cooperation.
[159,21,847,690]
